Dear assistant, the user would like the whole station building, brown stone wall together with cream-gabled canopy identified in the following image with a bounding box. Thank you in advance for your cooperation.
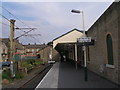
[53,2,120,84]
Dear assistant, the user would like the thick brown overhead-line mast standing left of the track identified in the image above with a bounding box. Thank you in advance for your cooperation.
[10,19,15,78]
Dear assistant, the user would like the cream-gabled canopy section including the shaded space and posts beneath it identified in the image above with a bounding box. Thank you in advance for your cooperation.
[53,29,84,68]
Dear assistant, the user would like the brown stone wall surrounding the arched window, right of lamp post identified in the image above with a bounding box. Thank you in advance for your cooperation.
[87,2,120,83]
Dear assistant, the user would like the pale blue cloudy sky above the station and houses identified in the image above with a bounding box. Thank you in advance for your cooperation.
[0,1,112,44]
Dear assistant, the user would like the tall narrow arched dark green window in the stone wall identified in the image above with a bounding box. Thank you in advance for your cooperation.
[106,34,114,65]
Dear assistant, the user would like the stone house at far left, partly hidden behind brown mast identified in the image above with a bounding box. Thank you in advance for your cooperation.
[0,38,25,61]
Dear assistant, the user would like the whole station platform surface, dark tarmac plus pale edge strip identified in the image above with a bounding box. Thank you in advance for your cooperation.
[36,62,118,90]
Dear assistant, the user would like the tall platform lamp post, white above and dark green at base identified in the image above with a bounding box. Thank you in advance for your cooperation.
[71,10,87,81]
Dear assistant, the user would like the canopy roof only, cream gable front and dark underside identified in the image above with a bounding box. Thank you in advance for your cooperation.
[53,29,84,52]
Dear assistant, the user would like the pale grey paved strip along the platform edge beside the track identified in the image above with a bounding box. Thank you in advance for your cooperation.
[36,62,59,90]
